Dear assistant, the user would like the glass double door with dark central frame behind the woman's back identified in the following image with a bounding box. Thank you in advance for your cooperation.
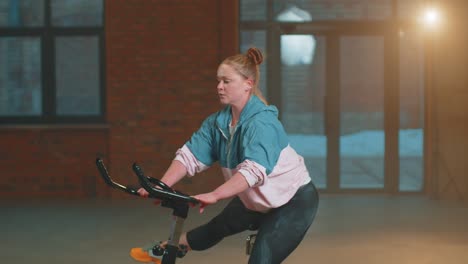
[280,34,385,191]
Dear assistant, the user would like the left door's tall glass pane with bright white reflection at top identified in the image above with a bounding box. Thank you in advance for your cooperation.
[280,35,327,188]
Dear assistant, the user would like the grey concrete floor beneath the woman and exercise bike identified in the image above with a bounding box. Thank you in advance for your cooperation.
[0,195,468,264]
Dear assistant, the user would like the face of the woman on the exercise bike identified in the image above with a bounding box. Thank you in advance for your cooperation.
[217,64,252,106]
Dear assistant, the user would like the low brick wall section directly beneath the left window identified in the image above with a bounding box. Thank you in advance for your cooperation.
[0,126,108,199]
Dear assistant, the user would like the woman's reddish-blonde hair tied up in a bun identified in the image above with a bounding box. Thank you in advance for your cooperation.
[221,47,268,105]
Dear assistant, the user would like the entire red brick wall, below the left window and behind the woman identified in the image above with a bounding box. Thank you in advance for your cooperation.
[0,0,238,197]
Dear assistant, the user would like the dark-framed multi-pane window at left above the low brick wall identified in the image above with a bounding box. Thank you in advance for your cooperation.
[0,0,105,124]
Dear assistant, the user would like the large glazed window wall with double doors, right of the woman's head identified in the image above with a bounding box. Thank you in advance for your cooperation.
[239,0,427,193]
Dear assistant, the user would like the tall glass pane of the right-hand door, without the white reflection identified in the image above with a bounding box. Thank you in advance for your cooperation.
[340,36,385,188]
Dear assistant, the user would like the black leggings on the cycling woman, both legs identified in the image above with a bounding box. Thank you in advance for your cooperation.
[187,182,319,264]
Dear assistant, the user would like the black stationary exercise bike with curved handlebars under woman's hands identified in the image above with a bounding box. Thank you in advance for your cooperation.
[96,158,199,264]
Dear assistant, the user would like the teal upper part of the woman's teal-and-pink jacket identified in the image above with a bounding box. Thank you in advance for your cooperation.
[186,95,289,175]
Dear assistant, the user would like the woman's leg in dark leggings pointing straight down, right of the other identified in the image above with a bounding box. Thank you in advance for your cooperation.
[249,182,319,264]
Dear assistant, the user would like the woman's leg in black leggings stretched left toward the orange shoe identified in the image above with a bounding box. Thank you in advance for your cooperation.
[186,197,265,250]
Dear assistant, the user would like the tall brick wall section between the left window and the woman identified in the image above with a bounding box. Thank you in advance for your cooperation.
[106,0,237,198]
